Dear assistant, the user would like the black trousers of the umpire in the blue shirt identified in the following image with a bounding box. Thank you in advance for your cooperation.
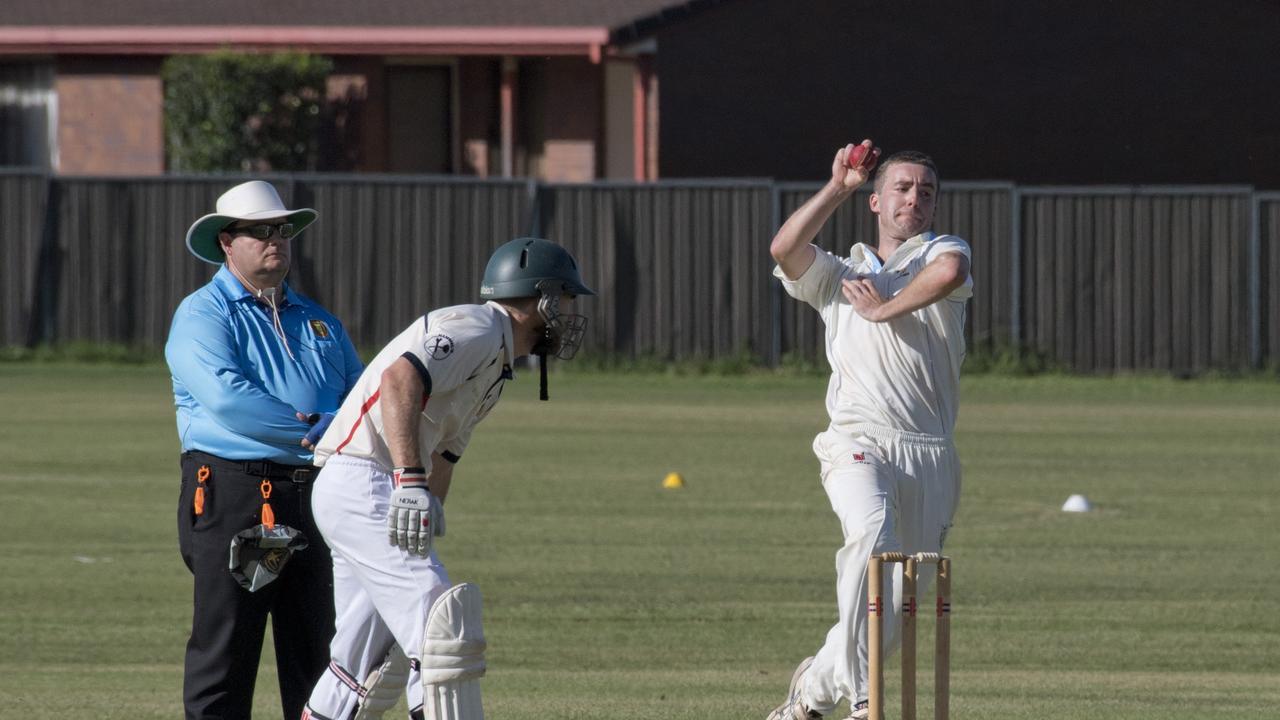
[178,452,334,720]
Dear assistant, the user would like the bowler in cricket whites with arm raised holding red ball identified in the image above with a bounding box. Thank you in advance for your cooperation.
[768,140,973,720]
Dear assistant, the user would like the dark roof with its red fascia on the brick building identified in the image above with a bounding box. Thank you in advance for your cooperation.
[0,0,721,55]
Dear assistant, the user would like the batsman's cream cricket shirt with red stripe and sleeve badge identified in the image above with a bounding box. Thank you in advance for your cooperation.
[314,302,515,470]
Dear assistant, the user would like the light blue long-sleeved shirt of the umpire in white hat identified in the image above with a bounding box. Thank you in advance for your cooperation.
[164,265,364,465]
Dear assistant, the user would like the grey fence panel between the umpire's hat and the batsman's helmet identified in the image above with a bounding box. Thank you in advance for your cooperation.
[289,176,530,348]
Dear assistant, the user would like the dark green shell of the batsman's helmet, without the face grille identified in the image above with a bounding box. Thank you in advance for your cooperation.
[480,237,595,300]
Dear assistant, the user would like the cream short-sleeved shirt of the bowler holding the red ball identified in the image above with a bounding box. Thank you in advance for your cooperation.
[773,232,973,438]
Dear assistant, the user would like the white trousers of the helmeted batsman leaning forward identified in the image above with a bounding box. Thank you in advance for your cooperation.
[307,455,449,719]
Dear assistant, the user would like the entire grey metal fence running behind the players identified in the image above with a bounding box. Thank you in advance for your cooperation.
[0,170,1280,373]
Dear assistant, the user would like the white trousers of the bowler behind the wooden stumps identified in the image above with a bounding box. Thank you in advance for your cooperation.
[801,425,960,715]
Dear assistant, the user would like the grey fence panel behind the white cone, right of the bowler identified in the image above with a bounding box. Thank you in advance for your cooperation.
[1021,188,1251,373]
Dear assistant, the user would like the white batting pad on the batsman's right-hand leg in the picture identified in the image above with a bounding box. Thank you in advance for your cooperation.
[421,583,485,720]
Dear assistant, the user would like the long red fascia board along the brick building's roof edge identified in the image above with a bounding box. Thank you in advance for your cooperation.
[0,26,609,59]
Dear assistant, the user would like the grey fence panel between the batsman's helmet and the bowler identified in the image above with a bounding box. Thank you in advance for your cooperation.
[540,182,772,359]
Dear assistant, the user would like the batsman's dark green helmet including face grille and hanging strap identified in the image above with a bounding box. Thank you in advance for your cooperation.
[480,237,595,379]
